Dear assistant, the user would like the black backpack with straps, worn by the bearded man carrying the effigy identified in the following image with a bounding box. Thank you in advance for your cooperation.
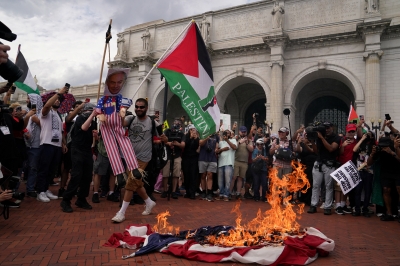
[128,116,168,173]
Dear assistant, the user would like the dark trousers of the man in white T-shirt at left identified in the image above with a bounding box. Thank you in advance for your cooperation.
[36,144,62,193]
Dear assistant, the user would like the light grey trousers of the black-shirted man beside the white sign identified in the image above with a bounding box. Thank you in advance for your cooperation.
[311,162,335,209]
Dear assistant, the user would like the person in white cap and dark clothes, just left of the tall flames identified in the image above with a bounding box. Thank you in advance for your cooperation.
[252,138,268,202]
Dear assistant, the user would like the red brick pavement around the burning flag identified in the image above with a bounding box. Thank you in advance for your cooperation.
[0,184,400,266]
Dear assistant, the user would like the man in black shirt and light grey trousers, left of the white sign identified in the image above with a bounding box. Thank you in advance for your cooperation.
[308,122,340,215]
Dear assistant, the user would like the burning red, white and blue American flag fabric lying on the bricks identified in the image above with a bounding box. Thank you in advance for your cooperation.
[104,225,335,265]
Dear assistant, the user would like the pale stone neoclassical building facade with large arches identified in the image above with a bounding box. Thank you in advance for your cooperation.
[74,0,400,132]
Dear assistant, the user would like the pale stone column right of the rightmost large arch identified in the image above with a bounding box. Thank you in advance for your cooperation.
[364,50,383,119]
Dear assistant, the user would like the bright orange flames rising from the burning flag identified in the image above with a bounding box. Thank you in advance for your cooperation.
[153,161,310,247]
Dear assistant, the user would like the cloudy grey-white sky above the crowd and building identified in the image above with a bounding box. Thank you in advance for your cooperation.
[0,0,258,90]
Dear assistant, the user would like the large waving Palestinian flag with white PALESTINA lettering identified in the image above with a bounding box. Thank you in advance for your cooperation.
[157,21,220,138]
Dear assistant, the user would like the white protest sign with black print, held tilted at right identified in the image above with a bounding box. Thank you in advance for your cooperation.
[331,161,361,194]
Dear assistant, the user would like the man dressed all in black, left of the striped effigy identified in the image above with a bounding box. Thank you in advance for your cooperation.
[60,103,96,212]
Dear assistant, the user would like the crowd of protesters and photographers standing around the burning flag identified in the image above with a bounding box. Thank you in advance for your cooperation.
[0,81,400,222]
